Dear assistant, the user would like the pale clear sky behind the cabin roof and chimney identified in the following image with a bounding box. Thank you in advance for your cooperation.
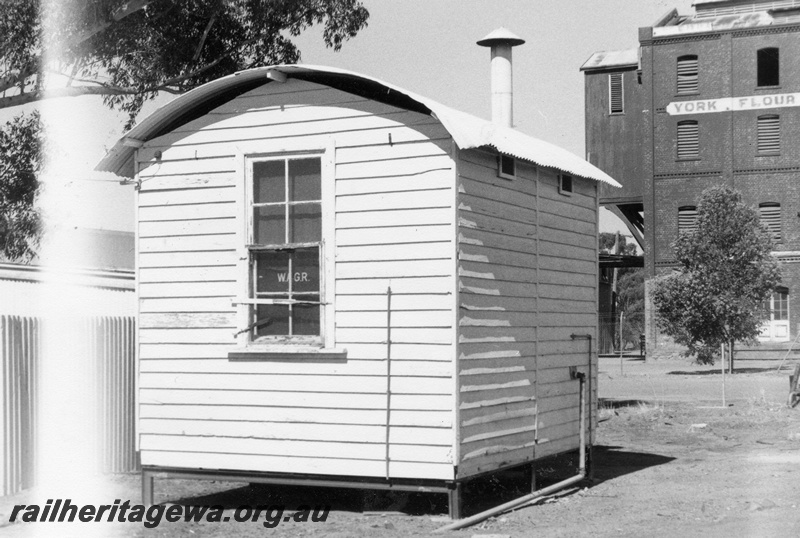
[7,0,692,231]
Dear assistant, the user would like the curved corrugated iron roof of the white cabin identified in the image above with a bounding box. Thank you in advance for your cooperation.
[97,65,621,187]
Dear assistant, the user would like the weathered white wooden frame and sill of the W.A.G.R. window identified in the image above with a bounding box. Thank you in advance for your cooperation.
[228,142,338,360]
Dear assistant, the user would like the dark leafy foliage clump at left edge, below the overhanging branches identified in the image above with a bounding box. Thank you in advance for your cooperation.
[0,112,42,261]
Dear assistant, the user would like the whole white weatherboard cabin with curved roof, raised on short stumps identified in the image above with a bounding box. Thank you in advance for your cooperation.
[99,28,616,517]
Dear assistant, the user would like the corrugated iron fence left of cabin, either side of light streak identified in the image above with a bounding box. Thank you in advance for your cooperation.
[0,316,138,495]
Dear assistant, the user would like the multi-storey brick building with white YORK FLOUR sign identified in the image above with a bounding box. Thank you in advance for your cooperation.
[581,0,800,349]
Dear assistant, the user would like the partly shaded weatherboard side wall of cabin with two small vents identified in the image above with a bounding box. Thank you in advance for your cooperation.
[458,150,598,477]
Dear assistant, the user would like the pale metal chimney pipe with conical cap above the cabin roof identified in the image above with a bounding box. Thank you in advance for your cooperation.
[478,28,525,127]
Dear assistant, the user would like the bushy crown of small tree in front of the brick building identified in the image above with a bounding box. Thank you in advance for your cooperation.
[653,186,780,370]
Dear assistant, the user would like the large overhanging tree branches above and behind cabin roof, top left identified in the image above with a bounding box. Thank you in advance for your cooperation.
[0,0,369,258]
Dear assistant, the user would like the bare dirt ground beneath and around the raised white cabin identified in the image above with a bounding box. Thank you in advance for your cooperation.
[0,358,800,538]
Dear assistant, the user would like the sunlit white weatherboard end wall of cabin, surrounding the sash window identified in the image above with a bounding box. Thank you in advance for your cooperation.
[138,79,456,479]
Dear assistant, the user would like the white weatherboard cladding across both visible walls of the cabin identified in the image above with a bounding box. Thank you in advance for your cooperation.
[115,68,598,480]
